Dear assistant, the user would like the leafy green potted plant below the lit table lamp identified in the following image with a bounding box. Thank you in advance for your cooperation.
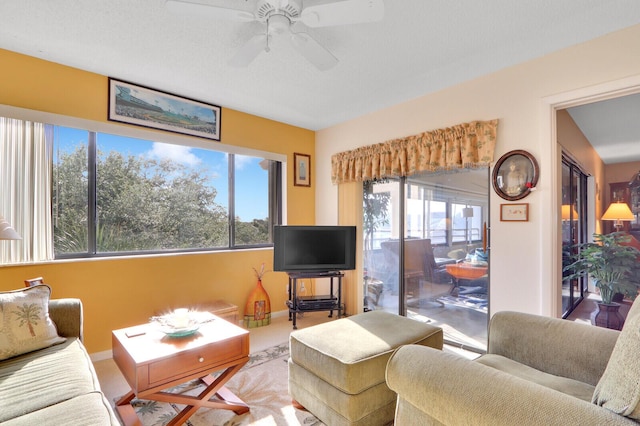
[563,232,640,330]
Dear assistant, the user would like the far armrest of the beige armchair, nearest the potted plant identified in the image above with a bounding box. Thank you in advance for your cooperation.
[487,311,620,386]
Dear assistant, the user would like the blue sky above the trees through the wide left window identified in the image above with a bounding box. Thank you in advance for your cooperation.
[56,126,269,221]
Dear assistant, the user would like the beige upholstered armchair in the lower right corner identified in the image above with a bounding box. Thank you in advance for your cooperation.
[386,304,640,426]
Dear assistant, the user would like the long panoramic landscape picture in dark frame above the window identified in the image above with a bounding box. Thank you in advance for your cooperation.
[108,77,222,141]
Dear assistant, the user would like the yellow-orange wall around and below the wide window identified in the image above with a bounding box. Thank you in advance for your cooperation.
[0,49,316,352]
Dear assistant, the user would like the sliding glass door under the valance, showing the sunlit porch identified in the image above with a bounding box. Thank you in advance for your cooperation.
[363,169,489,351]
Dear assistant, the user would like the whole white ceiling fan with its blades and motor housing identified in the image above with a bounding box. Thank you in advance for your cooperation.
[166,0,384,71]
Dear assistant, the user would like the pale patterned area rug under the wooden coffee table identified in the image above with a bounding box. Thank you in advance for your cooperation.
[131,343,323,426]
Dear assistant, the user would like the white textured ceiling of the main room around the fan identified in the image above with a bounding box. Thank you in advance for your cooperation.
[0,0,640,144]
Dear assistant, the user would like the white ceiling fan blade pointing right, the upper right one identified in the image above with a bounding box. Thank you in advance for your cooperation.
[300,0,384,27]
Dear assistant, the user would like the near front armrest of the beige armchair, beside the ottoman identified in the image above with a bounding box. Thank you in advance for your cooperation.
[386,345,636,426]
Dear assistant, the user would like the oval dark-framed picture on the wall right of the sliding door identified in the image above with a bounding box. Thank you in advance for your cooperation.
[492,149,538,201]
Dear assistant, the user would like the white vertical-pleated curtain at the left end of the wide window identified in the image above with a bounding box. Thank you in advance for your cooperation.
[0,117,53,265]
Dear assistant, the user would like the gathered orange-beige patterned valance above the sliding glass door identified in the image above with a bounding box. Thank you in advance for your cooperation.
[331,120,498,184]
